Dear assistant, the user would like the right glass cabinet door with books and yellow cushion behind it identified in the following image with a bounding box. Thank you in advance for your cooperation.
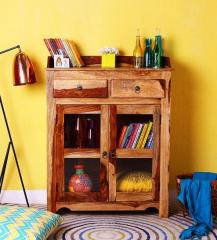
[109,105,160,201]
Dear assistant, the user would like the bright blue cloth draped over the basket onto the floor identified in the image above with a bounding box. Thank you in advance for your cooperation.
[178,172,217,240]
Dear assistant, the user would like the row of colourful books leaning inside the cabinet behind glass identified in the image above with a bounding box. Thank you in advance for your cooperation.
[118,121,153,149]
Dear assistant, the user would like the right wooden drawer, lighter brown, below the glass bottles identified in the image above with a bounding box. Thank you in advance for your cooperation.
[111,79,165,98]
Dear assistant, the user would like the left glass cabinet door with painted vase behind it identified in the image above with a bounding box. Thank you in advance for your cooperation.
[54,105,108,202]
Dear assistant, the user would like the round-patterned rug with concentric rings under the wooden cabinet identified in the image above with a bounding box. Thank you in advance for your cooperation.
[49,213,217,240]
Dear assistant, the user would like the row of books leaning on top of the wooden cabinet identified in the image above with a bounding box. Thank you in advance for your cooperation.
[44,38,84,67]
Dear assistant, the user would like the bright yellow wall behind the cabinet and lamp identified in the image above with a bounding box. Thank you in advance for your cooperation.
[0,0,217,189]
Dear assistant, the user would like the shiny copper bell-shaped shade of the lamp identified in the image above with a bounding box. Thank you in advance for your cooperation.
[14,52,36,86]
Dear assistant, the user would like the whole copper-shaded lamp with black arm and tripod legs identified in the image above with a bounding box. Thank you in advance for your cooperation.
[0,45,36,207]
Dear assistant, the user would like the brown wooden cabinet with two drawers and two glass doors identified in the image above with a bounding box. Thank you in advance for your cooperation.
[46,56,171,217]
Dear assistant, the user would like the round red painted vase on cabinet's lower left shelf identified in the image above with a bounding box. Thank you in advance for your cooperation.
[69,164,93,192]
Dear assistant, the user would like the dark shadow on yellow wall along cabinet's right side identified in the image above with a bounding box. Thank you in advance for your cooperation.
[170,56,196,189]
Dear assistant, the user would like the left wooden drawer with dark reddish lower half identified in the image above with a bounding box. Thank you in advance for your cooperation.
[53,80,108,98]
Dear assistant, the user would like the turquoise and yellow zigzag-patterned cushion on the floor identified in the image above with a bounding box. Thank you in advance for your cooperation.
[0,205,62,240]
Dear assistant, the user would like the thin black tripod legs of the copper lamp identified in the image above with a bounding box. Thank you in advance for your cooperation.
[0,96,29,207]
